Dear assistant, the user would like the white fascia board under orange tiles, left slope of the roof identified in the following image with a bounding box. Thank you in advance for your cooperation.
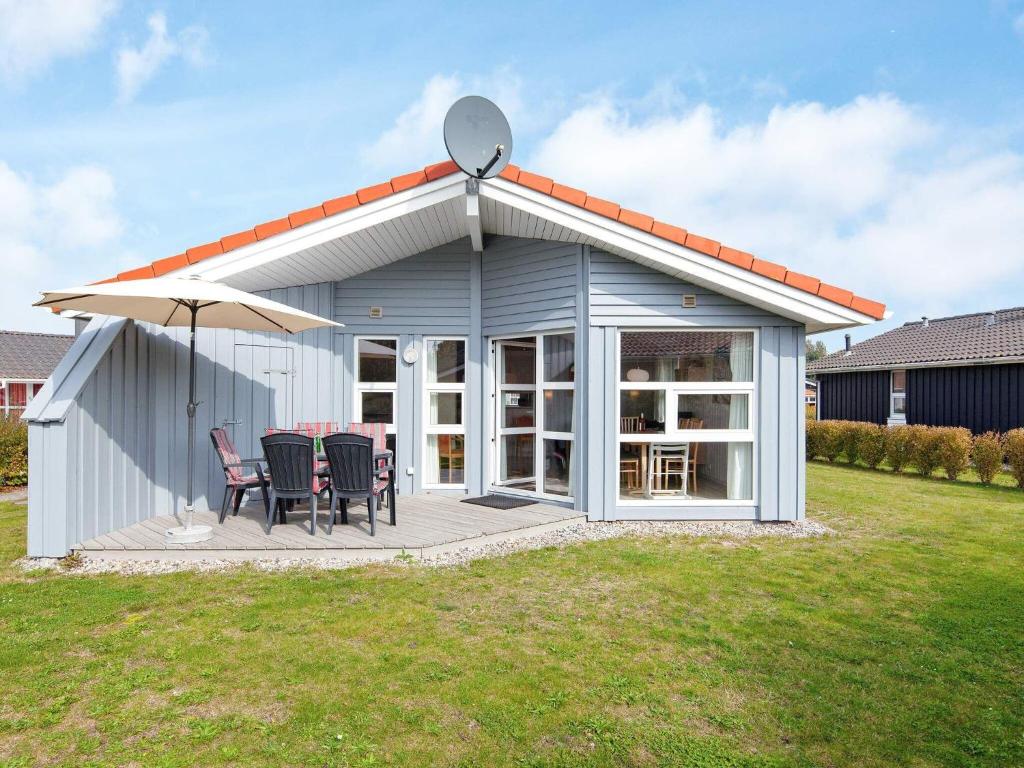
[169,173,466,281]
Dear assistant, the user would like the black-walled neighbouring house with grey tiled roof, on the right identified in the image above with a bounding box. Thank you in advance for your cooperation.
[807,307,1024,434]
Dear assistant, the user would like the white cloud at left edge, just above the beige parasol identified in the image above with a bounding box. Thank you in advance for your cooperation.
[0,162,122,332]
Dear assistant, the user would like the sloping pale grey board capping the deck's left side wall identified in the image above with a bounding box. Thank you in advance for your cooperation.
[22,315,129,422]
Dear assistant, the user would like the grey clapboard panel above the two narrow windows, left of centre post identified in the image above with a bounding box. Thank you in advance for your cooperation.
[334,239,470,335]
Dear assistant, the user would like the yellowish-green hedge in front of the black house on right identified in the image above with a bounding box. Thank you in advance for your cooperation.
[807,421,1024,487]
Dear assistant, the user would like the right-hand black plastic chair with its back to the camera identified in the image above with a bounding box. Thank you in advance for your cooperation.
[324,432,395,536]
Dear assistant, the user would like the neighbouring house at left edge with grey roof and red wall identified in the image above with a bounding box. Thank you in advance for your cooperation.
[0,331,75,417]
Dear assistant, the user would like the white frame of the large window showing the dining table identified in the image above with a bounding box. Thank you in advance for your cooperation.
[612,328,761,507]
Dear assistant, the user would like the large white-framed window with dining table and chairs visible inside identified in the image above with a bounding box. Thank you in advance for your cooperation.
[616,331,757,504]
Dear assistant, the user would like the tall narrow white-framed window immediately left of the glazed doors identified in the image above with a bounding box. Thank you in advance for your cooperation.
[423,338,466,486]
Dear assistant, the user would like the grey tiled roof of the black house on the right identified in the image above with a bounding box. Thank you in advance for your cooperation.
[807,307,1024,373]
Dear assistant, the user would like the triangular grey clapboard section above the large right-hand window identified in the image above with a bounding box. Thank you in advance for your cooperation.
[590,250,799,328]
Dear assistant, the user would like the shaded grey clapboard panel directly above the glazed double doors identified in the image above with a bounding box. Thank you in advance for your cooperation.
[480,238,582,336]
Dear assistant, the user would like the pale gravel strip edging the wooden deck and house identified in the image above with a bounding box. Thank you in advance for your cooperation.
[17,520,835,575]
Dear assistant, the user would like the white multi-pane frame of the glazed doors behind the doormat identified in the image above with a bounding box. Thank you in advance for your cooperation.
[489,328,580,503]
